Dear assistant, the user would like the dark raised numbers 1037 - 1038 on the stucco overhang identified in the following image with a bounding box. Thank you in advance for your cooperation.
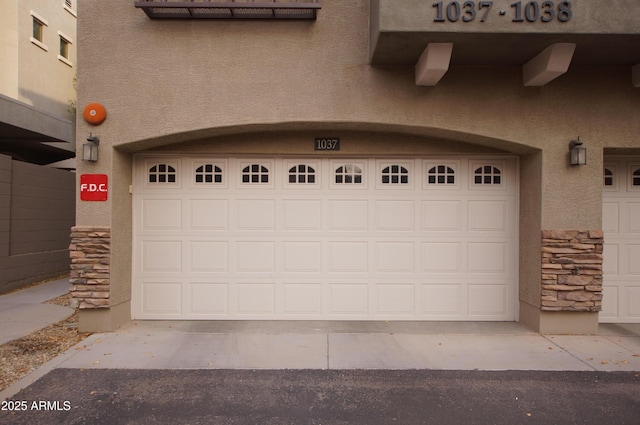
[433,0,573,23]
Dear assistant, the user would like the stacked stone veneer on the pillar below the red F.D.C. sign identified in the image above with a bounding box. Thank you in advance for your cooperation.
[69,226,111,309]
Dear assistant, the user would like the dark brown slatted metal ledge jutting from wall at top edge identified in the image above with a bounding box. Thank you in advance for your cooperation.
[135,0,322,19]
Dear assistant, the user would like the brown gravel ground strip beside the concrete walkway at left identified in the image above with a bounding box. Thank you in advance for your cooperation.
[0,294,91,391]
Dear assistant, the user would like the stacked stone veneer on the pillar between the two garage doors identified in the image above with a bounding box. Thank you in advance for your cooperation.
[541,230,604,312]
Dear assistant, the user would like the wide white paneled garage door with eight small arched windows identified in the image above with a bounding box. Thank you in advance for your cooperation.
[133,156,518,320]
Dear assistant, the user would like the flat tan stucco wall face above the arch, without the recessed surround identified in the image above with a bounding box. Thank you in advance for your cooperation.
[78,0,640,228]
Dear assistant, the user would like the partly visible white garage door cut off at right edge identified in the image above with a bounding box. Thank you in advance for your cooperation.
[600,158,640,323]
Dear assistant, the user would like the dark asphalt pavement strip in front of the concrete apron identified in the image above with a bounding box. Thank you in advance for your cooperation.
[0,369,640,425]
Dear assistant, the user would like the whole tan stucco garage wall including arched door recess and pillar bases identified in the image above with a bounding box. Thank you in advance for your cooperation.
[77,0,640,332]
